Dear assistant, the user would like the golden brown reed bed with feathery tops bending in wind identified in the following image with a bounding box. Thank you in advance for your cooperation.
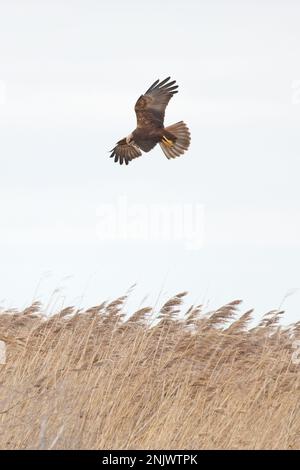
[0,293,300,449]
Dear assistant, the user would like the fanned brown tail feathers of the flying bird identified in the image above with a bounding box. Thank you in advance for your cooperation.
[159,121,191,158]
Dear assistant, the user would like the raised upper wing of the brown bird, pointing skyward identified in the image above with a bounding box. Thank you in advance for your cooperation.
[134,77,178,127]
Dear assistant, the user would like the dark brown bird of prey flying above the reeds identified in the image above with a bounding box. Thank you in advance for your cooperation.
[110,77,191,165]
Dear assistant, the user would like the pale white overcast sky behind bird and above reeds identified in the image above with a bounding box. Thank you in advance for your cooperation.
[0,0,300,321]
